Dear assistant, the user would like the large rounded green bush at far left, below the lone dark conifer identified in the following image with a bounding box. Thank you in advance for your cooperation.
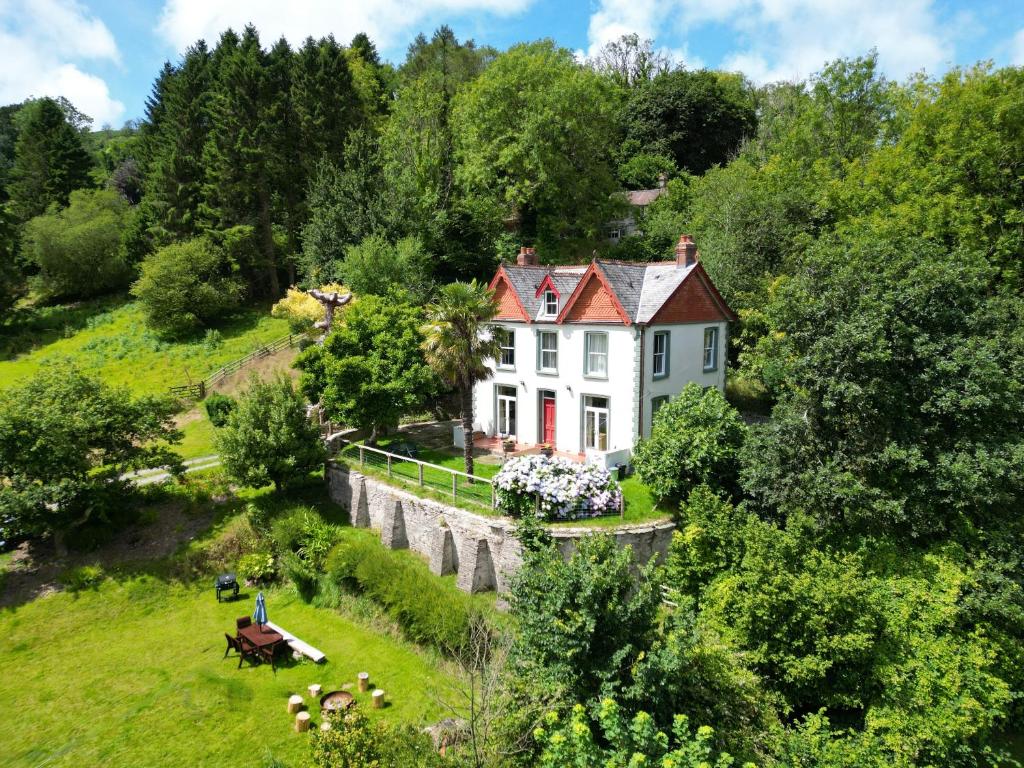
[23,189,131,299]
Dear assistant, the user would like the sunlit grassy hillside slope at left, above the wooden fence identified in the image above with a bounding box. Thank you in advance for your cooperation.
[0,299,288,394]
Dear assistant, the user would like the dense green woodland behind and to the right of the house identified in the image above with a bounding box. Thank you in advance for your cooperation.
[0,27,1024,768]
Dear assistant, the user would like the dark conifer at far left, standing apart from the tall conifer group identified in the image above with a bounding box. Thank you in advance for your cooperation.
[7,98,92,221]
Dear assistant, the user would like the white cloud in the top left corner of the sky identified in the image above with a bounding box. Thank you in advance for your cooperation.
[0,0,125,125]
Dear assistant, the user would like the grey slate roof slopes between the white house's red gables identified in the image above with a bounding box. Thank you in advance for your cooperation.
[503,259,724,323]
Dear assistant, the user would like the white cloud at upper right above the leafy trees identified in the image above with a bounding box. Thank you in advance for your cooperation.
[590,0,953,82]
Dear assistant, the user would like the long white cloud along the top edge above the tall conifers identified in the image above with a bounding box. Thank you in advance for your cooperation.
[158,0,532,51]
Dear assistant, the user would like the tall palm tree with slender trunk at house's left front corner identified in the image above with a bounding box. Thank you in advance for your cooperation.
[423,280,498,474]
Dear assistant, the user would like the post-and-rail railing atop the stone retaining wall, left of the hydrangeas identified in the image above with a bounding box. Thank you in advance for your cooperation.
[339,441,498,509]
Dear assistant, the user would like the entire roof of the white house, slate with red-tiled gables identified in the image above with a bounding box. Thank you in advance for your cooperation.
[490,249,736,325]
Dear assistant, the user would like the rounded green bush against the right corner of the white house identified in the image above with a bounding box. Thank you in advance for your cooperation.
[633,382,746,502]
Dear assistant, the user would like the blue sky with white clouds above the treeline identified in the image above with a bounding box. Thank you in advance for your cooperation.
[0,0,1024,127]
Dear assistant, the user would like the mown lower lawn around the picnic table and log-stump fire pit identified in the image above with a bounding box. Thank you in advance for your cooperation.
[0,578,445,768]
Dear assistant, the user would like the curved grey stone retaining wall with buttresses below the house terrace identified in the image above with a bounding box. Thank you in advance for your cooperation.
[326,462,675,593]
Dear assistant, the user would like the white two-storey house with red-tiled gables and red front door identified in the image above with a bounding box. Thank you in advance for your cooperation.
[473,234,736,466]
